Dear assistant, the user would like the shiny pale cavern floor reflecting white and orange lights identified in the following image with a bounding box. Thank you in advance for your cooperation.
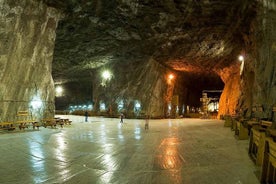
[0,116,259,184]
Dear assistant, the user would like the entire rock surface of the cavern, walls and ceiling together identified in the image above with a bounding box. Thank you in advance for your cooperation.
[0,0,276,118]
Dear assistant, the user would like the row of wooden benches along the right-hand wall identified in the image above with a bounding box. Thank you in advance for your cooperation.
[224,113,276,183]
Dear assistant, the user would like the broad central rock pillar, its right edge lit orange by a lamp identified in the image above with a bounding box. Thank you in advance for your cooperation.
[93,59,174,117]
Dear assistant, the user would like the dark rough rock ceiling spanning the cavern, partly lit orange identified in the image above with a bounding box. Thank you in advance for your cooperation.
[44,0,256,80]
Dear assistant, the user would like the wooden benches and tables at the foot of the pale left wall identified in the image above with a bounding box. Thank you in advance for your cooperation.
[0,111,72,130]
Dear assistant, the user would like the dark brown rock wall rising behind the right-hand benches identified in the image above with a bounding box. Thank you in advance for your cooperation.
[239,0,276,122]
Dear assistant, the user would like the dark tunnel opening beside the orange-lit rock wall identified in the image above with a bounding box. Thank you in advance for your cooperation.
[174,72,224,116]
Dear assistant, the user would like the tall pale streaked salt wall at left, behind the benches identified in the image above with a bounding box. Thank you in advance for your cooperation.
[0,0,59,121]
